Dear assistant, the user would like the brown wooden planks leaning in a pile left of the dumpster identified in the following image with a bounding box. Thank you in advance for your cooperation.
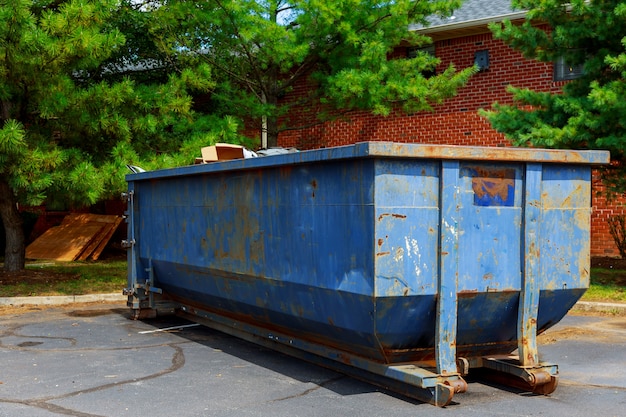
[26,213,122,261]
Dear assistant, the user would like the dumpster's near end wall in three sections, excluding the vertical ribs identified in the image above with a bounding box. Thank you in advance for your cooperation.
[376,161,590,362]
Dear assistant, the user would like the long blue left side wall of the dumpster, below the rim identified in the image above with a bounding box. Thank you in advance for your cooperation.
[135,160,386,357]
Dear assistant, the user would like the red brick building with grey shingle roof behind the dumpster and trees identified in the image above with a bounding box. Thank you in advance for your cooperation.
[270,0,626,256]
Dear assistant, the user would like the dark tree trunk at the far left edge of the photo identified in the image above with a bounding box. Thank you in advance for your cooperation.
[0,178,26,272]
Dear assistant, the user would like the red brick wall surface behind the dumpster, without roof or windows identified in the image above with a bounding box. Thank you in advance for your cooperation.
[270,29,626,256]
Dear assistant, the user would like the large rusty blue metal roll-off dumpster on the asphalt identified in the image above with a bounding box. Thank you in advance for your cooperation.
[125,142,609,406]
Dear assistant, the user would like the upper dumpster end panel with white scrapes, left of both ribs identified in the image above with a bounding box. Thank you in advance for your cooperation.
[375,160,440,297]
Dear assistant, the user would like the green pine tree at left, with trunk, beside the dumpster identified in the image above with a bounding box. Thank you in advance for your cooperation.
[0,0,227,271]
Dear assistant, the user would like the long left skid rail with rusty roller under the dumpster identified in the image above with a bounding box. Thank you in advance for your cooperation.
[178,306,467,407]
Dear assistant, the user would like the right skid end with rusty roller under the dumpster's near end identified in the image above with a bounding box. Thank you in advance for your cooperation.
[479,356,559,395]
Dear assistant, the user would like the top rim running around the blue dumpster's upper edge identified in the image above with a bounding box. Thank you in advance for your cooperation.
[126,142,610,181]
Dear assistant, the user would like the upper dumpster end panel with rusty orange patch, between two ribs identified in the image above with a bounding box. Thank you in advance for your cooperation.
[458,163,523,290]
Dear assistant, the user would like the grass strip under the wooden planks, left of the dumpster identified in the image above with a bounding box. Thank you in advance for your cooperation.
[0,260,127,297]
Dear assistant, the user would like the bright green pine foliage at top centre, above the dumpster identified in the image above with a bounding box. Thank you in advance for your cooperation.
[152,0,474,146]
